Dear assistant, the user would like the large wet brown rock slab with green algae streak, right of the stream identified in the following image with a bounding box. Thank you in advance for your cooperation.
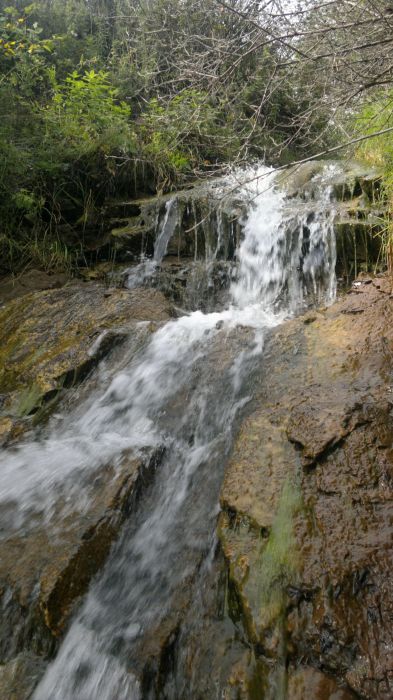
[219,278,393,700]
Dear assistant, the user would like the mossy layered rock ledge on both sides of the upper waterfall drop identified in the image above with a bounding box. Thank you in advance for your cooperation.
[113,161,386,302]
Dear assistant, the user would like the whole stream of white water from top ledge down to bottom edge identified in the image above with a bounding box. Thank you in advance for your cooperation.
[0,169,335,700]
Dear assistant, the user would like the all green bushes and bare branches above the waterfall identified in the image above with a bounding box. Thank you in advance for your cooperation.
[0,0,393,273]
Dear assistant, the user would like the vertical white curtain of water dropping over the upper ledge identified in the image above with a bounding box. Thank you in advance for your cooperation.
[231,167,336,313]
